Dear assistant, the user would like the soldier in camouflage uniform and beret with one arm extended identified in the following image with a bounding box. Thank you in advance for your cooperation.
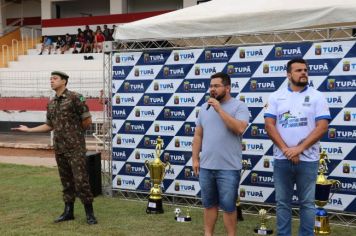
[13,71,97,224]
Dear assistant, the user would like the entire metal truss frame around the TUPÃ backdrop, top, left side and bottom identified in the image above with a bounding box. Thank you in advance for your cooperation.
[103,25,356,227]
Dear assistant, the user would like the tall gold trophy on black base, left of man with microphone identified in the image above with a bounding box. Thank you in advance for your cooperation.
[145,136,170,214]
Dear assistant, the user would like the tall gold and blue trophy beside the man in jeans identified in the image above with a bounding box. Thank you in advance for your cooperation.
[314,151,341,235]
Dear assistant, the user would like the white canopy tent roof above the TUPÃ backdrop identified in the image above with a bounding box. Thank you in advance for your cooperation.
[114,0,356,40]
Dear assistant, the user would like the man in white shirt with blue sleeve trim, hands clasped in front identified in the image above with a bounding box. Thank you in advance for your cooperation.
[264,58,331,236]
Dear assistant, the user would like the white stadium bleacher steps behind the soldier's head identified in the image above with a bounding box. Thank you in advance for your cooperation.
[0,41,103,97]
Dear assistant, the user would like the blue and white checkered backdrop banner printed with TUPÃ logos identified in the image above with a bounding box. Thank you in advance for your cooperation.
[112,41,356,212]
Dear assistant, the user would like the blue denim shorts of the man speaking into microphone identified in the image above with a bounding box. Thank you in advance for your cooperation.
[199,168,240,212]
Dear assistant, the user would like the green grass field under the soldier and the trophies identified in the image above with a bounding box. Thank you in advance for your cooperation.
[0,164,356,236]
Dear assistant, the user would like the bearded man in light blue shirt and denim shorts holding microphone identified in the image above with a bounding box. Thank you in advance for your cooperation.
[192,72,249,236]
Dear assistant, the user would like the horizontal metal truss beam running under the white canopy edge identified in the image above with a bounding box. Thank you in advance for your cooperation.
[112,25,356,51]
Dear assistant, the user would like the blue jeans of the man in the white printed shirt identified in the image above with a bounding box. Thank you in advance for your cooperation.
[273,159,318,236]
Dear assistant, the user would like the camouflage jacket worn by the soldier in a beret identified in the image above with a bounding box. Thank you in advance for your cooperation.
[46,89,91,153]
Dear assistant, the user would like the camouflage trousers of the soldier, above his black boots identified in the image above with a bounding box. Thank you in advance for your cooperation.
[56,151,93,204]
